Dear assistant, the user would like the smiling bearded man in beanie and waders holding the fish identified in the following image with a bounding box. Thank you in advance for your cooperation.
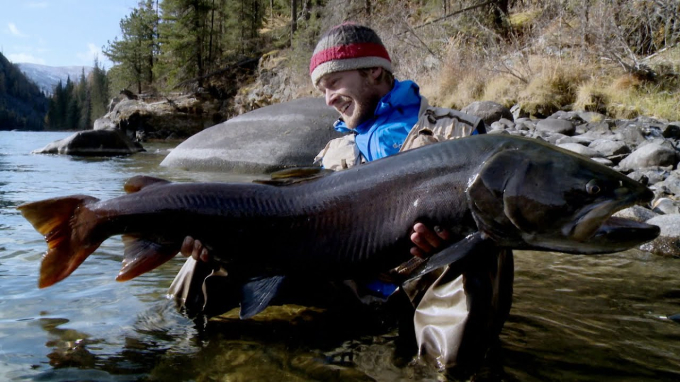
[173,23,513,374]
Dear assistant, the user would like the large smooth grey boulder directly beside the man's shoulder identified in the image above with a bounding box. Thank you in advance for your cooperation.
[161,98,341,174]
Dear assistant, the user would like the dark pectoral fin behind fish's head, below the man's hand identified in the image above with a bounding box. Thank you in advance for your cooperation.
[404,232,495,282]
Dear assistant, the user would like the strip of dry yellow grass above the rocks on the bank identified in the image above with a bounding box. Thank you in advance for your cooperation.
[421,48,680,121]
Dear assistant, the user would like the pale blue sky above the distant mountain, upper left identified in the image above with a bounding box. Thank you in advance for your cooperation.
[0,0,138,69]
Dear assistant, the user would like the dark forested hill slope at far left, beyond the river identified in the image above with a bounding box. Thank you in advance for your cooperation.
[0,53,48,130]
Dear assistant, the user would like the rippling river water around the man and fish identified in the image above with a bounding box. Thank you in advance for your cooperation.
[0,132,680,381]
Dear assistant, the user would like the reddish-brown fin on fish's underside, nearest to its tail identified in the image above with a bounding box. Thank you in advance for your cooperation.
[116,235,182,281]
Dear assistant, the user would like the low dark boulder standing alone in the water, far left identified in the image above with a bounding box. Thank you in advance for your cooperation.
[33,130,144,156]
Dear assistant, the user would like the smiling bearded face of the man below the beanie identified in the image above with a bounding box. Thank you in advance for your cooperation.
[318,70,384,129]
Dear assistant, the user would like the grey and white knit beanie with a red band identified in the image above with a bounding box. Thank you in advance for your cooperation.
[309,23,392,87]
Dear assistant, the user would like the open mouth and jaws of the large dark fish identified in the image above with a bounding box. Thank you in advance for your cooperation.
[570,191,660,253]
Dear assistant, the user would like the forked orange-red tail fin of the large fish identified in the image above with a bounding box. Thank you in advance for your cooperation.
[17,195,103,288]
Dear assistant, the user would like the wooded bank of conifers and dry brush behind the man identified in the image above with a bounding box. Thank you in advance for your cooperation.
[0,0,680,129]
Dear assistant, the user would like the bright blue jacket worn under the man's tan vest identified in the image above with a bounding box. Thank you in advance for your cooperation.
[334,80,420,162]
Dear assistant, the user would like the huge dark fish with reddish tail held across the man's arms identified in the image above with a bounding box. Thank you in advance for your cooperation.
[18,135,659,316]
